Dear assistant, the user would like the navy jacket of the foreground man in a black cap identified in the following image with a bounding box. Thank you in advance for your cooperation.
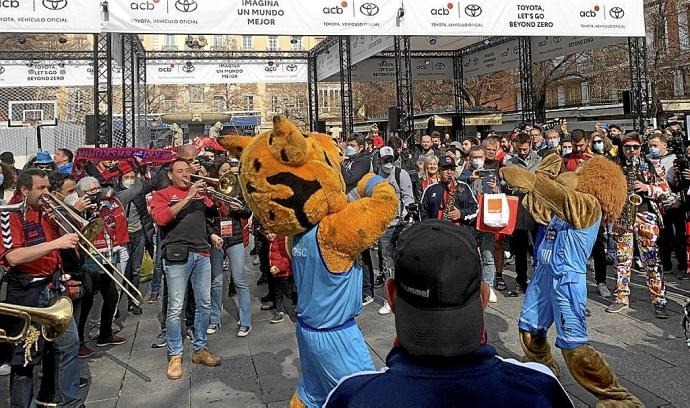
[324,345,573,408]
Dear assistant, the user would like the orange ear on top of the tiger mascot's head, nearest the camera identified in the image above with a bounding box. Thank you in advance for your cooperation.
[268,116,309,167]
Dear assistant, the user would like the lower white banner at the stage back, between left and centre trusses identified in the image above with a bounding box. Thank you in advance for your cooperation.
[146,61,307,85]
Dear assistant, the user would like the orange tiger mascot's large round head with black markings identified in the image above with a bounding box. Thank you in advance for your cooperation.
[218,116,347,236]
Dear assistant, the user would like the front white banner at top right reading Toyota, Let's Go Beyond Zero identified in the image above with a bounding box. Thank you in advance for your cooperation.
[403,0,645,37]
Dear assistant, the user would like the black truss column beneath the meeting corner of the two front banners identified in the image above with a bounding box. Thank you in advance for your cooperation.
[393,35,414,140]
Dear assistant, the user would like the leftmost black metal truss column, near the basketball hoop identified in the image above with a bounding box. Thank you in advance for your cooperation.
[93,33,117,147]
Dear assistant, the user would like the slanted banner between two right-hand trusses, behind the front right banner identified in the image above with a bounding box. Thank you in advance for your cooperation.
[462,40,520,78]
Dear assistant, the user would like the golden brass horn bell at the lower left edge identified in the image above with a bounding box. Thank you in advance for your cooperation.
[0,296,72,344]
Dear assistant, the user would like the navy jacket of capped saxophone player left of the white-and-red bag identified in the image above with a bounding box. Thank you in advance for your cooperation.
[420,181,479,225]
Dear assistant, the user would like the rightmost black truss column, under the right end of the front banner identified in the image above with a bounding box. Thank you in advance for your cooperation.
[628,37,651,132]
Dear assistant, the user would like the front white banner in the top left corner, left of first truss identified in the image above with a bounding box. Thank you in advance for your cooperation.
[0,0,101,33]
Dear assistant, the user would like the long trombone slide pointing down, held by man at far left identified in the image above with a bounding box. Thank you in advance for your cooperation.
[41,193,144,306]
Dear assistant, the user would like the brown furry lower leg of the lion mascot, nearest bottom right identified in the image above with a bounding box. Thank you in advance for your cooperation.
[561,345,644,408]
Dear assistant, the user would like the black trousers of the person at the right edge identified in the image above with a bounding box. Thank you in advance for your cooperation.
[657,208,688,271]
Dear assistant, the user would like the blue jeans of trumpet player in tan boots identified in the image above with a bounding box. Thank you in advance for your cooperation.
[164,251,211,356]
